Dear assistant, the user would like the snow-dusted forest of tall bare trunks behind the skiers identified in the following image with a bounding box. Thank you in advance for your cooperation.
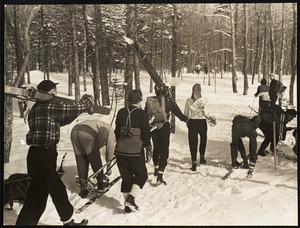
[3,3,297,162]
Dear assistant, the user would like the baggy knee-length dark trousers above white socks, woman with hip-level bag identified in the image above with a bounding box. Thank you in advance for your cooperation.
[116,152,148,192]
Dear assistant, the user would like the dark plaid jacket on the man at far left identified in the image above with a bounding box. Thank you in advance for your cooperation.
[26,98,92,146]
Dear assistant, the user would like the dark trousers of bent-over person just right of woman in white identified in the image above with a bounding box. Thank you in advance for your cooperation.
[230,124,257,164]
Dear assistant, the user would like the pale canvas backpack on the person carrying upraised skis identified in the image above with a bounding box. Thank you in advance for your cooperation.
[146,95,168,129]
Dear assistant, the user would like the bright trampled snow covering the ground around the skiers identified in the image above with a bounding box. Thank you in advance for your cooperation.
[3,71,298,226]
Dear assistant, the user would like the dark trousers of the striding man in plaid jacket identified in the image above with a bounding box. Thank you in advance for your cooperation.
[16,146,74,225]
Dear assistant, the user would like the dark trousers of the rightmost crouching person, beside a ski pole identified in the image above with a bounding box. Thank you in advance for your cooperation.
[259,121,279,151]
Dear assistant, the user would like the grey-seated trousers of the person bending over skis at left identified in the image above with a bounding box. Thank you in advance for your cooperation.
[71,125,103,182]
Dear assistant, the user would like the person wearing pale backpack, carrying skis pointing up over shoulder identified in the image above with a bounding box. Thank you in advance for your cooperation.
[145,85,188,184]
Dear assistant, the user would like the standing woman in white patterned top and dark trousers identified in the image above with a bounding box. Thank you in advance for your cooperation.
[184,83,207,171]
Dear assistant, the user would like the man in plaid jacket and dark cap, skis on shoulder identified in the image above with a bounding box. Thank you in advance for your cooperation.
[16,80,93,226]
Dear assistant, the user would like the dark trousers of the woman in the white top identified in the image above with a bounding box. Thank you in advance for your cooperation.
[187,119,207,162]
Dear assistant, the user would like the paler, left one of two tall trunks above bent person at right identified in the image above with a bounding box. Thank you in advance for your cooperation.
[229,4,237,93]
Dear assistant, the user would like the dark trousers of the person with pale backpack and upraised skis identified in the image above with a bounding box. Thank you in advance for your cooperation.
[151,122,171,172]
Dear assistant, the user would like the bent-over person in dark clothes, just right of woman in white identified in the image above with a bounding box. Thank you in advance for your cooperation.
[230,115,261,169]
